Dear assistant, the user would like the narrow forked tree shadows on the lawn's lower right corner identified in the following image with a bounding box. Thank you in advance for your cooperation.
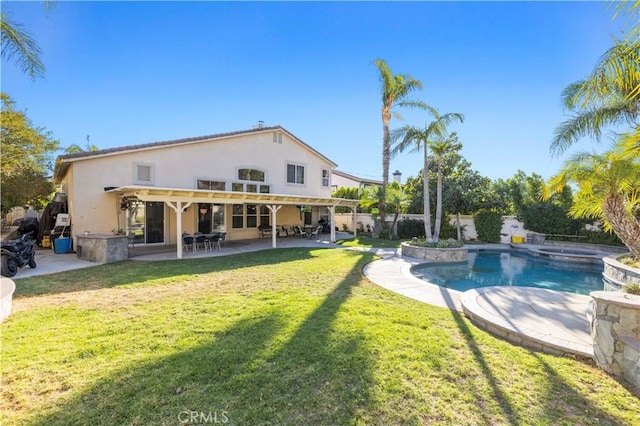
[443,292,626,425]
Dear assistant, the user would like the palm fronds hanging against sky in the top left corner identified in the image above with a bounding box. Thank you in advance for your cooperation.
[0,10,49,79]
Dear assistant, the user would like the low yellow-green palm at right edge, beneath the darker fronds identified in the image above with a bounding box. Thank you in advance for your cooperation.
[543,141,640,259]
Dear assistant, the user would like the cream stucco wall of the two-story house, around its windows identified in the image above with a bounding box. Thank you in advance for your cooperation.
[62,131,334,243]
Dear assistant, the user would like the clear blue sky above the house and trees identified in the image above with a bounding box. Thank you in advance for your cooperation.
[1,1,620,180]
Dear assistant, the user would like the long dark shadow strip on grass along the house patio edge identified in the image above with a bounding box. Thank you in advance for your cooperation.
[14,247,340,299]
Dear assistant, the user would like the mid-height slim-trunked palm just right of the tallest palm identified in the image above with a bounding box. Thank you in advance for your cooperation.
[392,107,464,241]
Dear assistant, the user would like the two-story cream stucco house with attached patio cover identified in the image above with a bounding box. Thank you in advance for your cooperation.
[54,125,357,258]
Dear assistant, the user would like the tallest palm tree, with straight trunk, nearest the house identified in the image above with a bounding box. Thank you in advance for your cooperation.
[374,59,428,233]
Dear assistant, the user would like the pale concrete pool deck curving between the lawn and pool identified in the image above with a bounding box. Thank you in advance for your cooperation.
[364,245,593,358]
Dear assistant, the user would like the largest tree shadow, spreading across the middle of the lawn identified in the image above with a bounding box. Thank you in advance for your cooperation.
[31,258,373,425]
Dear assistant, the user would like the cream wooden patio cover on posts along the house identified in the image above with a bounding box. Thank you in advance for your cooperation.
[105,186,360,259]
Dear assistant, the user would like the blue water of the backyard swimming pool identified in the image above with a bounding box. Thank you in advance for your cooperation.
[412,252,604,294]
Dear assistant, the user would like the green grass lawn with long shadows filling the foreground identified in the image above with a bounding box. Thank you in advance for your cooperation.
[0,248,640,425]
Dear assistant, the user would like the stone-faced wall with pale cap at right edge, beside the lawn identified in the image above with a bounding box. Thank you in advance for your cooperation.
[591,291,640,392]
